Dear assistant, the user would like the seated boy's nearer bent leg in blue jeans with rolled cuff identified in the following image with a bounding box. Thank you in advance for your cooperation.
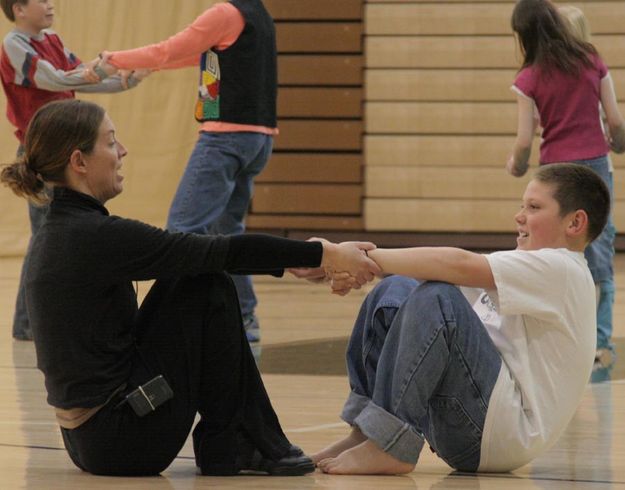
[344,283,501,470]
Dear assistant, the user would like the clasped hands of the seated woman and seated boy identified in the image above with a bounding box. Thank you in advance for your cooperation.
[288,238,382,296]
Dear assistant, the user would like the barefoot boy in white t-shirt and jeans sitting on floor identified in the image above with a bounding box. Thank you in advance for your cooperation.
[299,164,610,474]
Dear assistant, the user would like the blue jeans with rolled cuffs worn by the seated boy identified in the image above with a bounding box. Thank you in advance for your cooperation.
[341,276,502,471]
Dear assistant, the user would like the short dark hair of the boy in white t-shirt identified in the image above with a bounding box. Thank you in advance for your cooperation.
[534,163,611,243]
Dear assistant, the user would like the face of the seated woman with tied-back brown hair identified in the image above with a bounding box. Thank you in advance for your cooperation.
[83,114,128,203]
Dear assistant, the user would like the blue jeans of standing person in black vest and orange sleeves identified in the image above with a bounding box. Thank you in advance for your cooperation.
[167,132,273,315]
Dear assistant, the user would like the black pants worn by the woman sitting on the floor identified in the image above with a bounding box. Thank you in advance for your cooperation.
[62,273,290,475]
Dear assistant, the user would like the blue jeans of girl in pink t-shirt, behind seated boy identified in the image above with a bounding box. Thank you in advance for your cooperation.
[575,156,616,349]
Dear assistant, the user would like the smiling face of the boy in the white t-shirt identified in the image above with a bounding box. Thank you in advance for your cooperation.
[514,180,571,250]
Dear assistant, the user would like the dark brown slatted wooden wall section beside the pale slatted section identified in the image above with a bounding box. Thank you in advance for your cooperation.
[247,0,364,234]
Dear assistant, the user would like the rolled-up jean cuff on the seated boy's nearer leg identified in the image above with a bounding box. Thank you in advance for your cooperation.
[354,401,424,464]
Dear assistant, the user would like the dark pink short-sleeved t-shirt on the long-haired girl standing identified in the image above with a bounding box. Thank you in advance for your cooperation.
[512,56,609,164]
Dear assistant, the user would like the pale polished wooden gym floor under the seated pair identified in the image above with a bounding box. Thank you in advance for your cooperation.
[0,256,625,490]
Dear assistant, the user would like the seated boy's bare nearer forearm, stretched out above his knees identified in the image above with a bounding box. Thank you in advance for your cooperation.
[368,247,495,289]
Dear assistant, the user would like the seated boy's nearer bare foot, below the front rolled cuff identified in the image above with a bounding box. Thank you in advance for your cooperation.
[317,440,415,475]
